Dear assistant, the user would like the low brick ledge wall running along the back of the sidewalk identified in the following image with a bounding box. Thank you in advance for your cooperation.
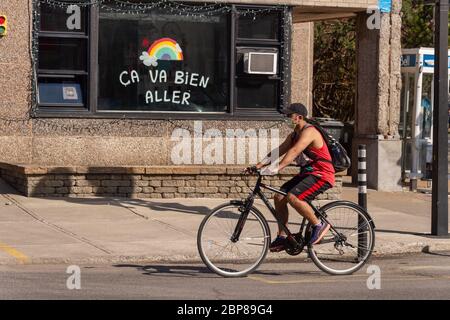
[0,164,342,200]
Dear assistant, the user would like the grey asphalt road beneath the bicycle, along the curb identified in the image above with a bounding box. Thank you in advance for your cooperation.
[0,252,450,300]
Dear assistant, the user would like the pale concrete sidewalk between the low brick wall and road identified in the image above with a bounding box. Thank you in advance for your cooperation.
[0,179,450,264]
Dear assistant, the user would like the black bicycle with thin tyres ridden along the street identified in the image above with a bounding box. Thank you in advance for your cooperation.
[197,170,375,277]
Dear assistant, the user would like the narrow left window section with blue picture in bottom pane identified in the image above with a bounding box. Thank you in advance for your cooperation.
[37,3,89,110]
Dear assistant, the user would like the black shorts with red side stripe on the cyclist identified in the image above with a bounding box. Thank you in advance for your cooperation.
[280,174,332,201]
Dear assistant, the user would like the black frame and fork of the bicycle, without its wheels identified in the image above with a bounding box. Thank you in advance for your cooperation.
[231,172,346,245]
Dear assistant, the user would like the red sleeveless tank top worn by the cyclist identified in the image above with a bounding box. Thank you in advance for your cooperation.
[293,125,335,186]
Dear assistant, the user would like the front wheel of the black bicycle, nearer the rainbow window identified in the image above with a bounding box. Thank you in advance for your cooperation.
[197,203,270,277]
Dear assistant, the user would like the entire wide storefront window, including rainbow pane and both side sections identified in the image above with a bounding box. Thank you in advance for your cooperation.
[34,0,288,118]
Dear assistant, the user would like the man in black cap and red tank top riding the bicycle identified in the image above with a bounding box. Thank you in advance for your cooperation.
[247,103,335,252]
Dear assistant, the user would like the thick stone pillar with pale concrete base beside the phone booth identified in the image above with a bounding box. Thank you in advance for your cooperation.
[352,0,402,191]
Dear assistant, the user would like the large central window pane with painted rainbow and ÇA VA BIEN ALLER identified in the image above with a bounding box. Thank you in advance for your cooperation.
[98,11,229,112]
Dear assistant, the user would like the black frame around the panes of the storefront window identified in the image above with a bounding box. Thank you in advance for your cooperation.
[33,4,292,120]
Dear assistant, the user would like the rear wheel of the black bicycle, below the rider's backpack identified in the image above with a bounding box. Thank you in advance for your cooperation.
[308,201,375,275]
